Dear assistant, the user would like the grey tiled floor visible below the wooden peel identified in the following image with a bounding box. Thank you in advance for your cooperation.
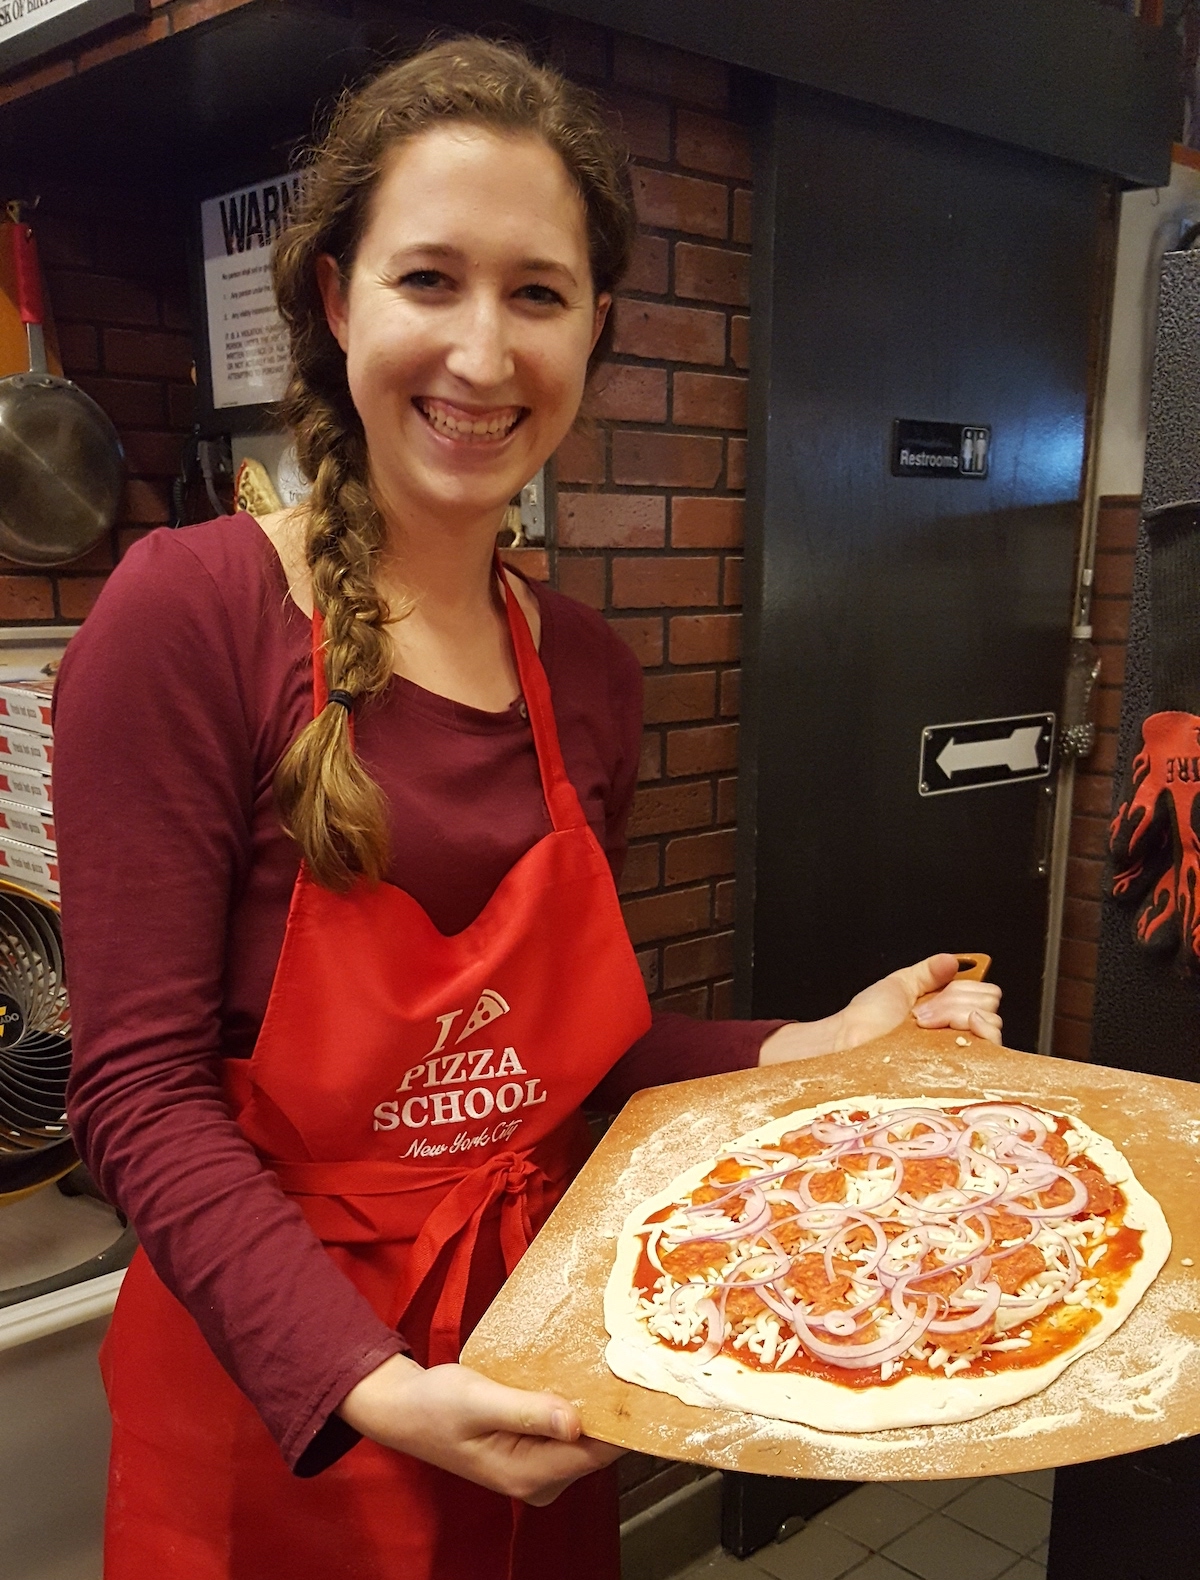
[677,1471,1055,1580]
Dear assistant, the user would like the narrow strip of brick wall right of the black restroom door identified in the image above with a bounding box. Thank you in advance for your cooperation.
[1053,496,1140,1059]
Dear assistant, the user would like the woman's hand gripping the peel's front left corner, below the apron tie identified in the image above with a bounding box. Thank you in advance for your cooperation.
[338,1356,623,1506]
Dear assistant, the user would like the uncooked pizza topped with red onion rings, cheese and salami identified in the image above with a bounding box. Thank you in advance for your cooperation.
[604,1097,1170,1431]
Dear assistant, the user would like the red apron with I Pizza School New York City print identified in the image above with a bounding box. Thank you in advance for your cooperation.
[101,588,650,1580]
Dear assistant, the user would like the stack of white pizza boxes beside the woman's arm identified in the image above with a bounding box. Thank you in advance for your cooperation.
[0,679,58,904]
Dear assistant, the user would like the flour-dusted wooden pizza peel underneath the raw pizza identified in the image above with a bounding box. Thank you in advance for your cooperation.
[462,1022,1200,1482]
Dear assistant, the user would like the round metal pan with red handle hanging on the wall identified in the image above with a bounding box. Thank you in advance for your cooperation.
[0,224,125,566]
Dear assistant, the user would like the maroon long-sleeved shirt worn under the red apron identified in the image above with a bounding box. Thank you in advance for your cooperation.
[54,515,779,1474]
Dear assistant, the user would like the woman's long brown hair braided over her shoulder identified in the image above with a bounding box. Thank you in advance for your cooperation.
[272,38,634,891]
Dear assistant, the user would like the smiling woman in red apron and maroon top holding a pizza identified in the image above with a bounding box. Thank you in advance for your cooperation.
[55,30,999,1580]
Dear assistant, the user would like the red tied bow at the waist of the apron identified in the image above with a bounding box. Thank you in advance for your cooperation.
[392,1152,547,1367]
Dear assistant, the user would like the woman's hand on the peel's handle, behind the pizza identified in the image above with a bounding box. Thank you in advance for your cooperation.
[759,954,1002,1065]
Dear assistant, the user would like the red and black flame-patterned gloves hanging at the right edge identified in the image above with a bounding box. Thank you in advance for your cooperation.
[1108,713,1200,961]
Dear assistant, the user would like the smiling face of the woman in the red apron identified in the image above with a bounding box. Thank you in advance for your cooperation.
[321,123,609,526]
